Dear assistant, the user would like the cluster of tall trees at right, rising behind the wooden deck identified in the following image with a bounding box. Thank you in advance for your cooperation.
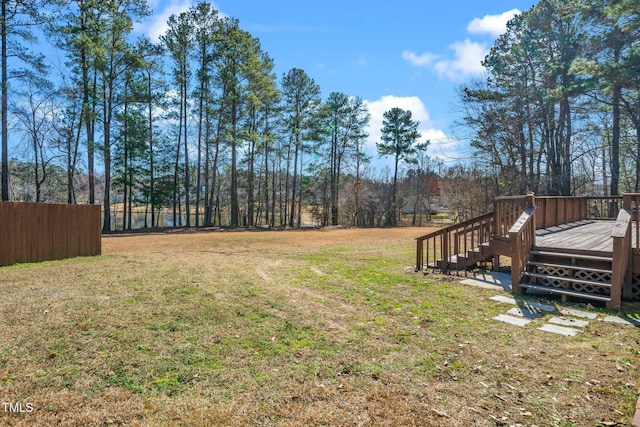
[461,0,640,195]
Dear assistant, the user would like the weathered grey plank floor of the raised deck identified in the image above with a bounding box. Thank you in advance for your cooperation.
[536,220,636,254]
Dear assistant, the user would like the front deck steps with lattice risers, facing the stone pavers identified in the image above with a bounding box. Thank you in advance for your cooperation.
[520,246,613,303]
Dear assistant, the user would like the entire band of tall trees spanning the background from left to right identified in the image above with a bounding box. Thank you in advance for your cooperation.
[0,0,640,231]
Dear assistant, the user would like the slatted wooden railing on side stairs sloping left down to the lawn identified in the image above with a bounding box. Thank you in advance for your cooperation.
[416,212,494,272]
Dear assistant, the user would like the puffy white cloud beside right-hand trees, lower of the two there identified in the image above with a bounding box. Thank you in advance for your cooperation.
[433,39,489,80]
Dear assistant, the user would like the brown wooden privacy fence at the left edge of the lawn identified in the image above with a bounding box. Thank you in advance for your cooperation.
[0,202,101,266]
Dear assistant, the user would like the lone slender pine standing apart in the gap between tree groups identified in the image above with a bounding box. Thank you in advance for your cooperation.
[376,107,421,226]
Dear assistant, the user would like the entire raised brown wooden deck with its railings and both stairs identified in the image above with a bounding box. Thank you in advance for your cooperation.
[416,193,640,309]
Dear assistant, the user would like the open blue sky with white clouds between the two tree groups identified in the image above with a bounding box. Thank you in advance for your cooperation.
[135,0,536,165]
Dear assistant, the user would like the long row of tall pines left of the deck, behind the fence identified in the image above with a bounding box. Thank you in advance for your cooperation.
[2,0,444,231]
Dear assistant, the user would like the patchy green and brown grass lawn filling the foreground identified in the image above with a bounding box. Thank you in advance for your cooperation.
[0,228,640,426]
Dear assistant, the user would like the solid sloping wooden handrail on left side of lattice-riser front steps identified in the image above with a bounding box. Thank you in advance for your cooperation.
[509,205,536,294]
